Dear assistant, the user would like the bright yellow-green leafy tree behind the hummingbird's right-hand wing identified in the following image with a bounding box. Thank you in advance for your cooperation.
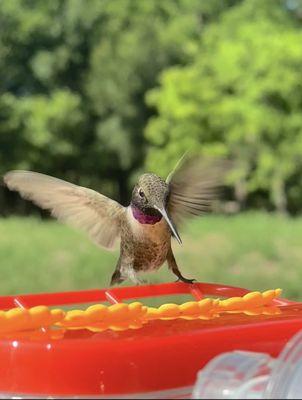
[146,0,302,211]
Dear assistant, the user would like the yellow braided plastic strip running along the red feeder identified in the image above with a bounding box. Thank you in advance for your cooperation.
[0,289,282,335]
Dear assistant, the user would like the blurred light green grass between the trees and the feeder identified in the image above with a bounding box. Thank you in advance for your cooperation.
[0,213,302,300]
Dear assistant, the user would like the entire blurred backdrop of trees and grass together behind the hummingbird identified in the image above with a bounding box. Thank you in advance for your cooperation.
[0,0,302,299]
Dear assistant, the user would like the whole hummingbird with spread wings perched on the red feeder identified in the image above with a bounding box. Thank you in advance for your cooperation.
[4,156,225,285]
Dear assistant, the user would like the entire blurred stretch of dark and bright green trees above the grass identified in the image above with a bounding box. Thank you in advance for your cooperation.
[0,0,302,212]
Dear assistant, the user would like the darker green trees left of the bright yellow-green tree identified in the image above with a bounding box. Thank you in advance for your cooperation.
[0,0,212,206]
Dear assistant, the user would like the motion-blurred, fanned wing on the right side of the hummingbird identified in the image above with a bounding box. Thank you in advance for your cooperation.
[167,156,229,224]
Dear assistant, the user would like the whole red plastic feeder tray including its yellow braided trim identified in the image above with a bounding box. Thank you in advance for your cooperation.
[0,282,302,398]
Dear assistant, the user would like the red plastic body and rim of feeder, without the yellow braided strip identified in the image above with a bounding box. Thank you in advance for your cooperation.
[0,283,302,398]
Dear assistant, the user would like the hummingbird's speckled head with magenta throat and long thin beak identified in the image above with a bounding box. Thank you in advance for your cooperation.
[131,173,181,243]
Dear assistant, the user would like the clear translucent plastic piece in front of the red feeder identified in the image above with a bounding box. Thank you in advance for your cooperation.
[192,331,302,399]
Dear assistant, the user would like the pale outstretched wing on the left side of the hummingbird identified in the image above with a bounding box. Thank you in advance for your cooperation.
[4,171,125,248]
